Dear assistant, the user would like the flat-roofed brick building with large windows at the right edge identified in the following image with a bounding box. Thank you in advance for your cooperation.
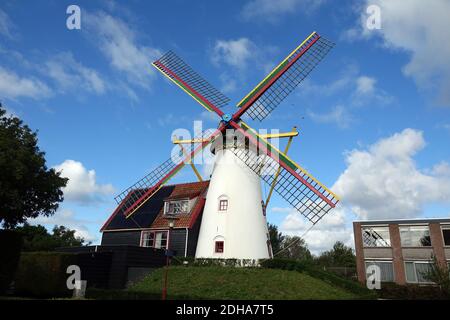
[353,219,450,285]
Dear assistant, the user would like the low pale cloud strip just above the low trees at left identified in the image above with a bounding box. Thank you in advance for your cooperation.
[29,209,98,242]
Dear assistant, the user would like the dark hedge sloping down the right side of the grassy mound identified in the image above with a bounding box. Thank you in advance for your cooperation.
[261,259,377,299]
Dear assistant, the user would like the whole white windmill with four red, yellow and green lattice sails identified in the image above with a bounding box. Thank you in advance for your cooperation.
[116,32,339,259]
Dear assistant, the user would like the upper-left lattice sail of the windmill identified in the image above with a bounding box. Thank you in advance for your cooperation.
[153,51,230,111]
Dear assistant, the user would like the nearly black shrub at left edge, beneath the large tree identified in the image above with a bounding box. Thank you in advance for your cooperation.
[0,230,22,294]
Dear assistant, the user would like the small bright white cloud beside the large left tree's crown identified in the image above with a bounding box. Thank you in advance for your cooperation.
[54,160,115,204]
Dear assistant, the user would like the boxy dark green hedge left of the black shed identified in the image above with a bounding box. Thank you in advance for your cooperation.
[15,252,77,298]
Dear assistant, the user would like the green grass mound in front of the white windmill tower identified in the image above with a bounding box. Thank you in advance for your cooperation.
[129,266,361,300]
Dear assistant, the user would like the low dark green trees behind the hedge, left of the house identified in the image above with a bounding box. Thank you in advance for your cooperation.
[15,222,86,251]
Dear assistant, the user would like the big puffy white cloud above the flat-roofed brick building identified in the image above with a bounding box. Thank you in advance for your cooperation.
[332,129,450,219]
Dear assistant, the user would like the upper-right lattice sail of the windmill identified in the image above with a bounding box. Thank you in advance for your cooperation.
[238,33,334,121]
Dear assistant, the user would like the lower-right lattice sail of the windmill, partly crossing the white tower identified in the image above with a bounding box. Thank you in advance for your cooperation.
[230,121,339,224]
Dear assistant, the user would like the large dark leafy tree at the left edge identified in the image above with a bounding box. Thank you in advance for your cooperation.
[0,103,67,228]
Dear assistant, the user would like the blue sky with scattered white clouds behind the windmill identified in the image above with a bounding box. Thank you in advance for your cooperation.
[0,0,450,252]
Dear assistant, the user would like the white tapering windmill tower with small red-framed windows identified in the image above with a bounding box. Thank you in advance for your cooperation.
[195,131,272,259]
